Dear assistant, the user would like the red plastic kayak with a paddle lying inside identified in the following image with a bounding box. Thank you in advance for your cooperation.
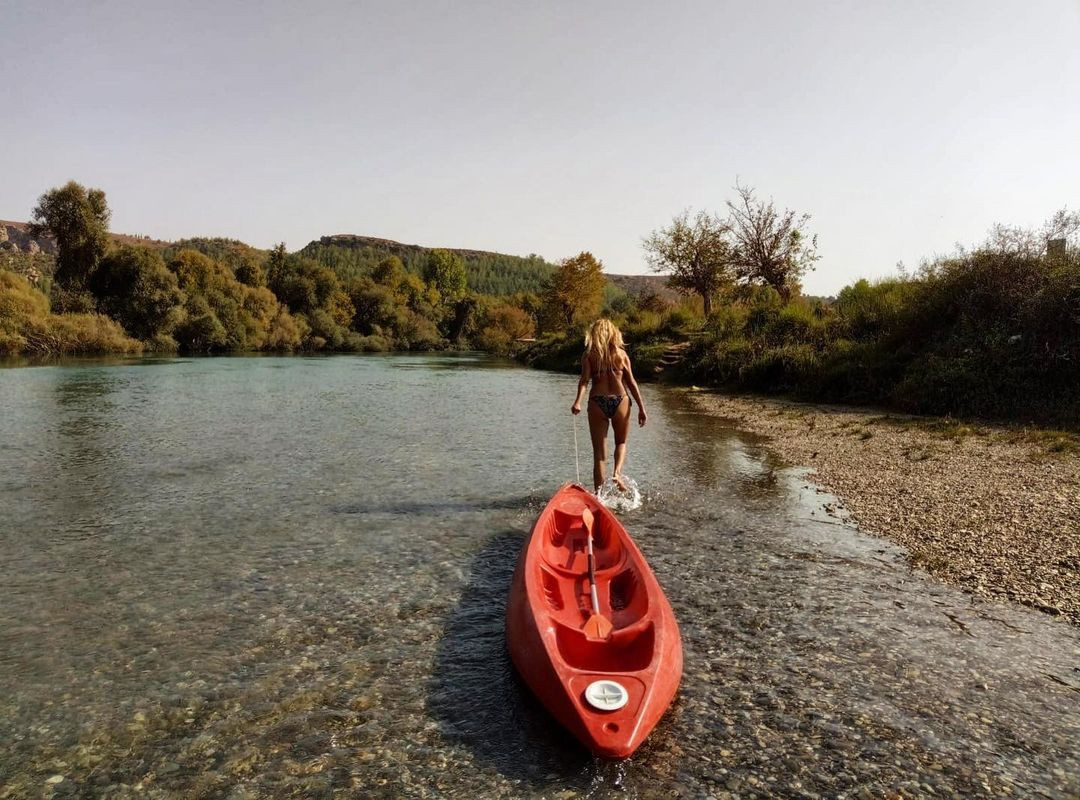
[507,484,683,758]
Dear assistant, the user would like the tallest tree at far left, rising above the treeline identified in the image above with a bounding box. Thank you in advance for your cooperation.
[30,180,109,291]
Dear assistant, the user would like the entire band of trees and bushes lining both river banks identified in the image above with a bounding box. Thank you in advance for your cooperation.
[0,182,1080,424]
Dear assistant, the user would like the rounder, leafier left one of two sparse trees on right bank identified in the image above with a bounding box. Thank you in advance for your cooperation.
[644,211,734,316]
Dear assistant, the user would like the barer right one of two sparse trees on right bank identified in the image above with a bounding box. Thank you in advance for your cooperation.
[728,184,819,300]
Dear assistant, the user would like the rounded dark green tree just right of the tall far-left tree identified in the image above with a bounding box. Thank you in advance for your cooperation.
[89,246,184,340]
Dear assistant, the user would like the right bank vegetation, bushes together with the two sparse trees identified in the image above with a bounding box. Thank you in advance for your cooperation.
[527,197,1080,428]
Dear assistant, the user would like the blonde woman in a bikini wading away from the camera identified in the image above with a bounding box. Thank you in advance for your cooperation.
[570,318,649,491]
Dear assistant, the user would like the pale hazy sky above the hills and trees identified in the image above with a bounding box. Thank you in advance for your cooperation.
[0,0,1080,295]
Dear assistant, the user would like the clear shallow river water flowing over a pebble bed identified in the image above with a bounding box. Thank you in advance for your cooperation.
[0,356,1080,799]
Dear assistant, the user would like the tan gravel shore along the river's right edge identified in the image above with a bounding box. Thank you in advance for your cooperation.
[690,391,1080,624]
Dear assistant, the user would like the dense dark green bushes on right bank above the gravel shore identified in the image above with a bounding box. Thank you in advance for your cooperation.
[688,224,1080,420]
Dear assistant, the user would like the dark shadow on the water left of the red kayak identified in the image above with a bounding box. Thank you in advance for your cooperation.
[428,531,593,784]
